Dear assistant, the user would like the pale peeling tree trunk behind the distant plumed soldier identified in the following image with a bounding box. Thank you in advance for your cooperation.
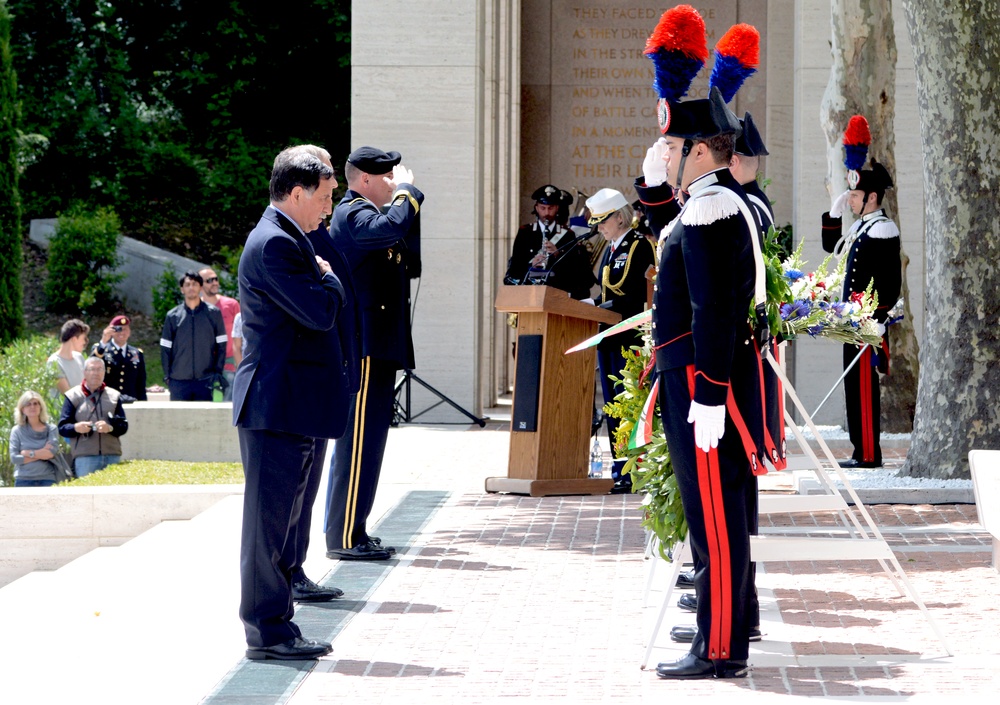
[820,0,923,433]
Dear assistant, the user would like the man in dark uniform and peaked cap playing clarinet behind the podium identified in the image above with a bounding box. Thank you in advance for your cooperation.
[504,184,594,299]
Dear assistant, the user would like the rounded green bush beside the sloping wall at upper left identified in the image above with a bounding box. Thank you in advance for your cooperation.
[45,204,123,313]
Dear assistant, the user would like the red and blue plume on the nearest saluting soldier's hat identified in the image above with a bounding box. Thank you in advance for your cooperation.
[645,5,708,103]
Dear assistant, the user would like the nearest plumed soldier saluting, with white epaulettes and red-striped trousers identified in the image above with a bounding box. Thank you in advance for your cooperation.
[646,6,763,679]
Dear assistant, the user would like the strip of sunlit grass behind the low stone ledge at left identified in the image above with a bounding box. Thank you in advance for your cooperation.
[66,456,243,487]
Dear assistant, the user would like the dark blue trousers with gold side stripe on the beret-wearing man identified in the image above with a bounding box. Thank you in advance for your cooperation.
[325,357,397,550]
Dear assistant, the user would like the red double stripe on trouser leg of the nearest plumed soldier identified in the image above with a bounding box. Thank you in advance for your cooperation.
[687,365,733,659]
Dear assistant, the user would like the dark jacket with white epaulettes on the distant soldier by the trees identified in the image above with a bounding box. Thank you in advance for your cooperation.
[823,208,903,323]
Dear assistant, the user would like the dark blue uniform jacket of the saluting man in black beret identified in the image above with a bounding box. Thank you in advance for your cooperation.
[330,184,424,369]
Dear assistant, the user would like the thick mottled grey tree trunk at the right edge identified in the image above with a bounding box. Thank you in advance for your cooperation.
[903,0,1000,477]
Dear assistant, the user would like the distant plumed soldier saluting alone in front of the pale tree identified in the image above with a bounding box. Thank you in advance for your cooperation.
[823,116,903,468]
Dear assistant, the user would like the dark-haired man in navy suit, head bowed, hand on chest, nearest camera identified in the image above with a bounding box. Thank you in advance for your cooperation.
[233,147,350,660]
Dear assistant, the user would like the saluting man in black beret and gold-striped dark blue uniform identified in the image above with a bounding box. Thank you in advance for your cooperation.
[326,147,424,560]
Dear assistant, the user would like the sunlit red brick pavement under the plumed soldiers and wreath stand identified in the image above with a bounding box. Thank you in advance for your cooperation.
[276,493,1000,705]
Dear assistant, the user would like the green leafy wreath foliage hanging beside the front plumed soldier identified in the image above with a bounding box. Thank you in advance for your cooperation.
[604,331,687,560]
